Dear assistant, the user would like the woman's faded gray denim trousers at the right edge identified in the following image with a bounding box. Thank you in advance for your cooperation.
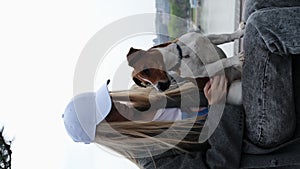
[242,0,300,147]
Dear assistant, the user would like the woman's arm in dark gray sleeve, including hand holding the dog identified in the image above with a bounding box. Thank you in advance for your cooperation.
[204,75,244,169]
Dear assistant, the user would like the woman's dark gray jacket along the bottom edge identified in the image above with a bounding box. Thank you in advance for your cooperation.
[137,105,300,169]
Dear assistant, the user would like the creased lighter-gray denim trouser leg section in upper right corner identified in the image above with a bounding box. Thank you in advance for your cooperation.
[249,7,300,55]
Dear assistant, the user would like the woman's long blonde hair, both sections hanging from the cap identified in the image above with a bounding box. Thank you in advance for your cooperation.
[95,83,206,163]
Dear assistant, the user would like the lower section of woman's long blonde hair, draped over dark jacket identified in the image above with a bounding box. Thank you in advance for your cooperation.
[95,119,202,162]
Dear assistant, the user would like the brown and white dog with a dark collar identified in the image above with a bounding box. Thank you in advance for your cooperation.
[127,23,245,105]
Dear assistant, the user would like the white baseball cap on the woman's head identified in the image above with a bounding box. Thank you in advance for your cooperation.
[63,80,112,144]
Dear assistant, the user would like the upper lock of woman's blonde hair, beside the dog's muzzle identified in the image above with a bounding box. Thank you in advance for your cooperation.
[110,82,200,110]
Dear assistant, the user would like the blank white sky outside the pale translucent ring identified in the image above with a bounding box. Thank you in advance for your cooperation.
[0,0,155,169]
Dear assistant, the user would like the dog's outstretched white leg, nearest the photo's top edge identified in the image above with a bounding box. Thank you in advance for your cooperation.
[207,22,245,45]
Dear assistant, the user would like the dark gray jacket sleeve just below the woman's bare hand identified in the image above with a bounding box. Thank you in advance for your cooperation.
[206,105,244,169]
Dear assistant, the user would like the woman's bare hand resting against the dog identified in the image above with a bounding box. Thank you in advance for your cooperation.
[204,75,227,105]
